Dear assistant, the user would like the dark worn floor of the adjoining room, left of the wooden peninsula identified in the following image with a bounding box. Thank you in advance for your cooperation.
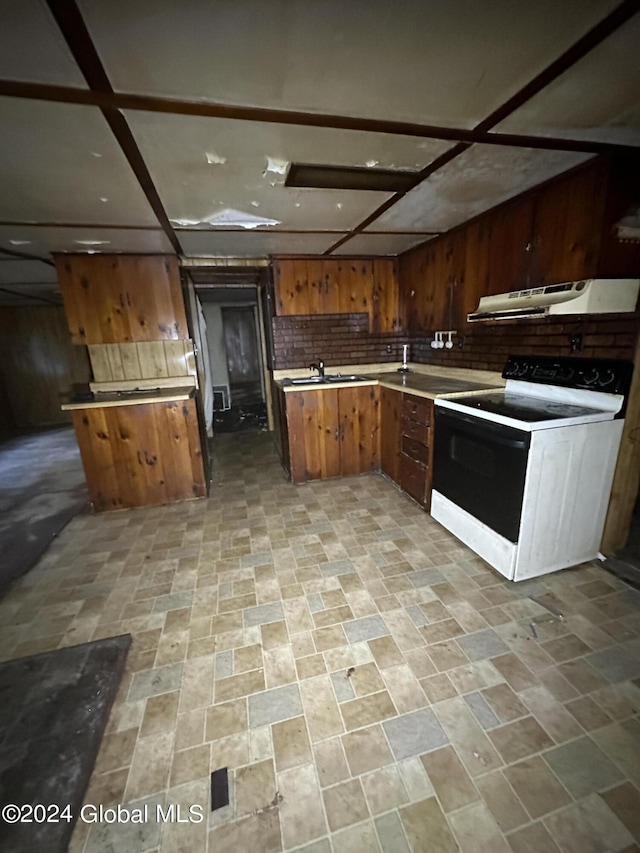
[0,427,89,594]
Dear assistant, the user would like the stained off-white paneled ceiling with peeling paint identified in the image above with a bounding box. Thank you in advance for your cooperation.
[0,0,640,302]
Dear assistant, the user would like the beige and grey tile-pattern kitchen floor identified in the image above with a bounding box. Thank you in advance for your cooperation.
[0,434,640,853]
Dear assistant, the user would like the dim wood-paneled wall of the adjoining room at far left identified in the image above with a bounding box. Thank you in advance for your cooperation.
[0,306,91,429]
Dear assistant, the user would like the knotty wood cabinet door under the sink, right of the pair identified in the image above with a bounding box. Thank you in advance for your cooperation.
[340,385,380,476]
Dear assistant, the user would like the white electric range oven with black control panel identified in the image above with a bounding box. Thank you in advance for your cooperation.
[431,356,633,581]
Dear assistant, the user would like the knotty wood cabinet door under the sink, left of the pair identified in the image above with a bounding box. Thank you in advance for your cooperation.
[286,388,340,483]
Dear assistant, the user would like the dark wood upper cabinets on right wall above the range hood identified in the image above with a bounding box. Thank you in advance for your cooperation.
[398,158,640,333]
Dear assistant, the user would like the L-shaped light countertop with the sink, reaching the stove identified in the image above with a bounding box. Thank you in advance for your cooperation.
[276,365,504,400]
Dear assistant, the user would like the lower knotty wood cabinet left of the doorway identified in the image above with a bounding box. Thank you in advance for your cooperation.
[73,399,206,511]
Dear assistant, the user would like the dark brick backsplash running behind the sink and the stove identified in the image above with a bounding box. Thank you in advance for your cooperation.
[273,314,640,371]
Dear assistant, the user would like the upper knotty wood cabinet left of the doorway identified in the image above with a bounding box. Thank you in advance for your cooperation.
[54,255,189,344]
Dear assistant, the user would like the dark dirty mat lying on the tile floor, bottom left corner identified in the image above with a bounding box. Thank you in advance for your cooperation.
[0,634,131,853]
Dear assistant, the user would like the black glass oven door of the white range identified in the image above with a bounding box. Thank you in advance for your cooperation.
[433,405,531,542]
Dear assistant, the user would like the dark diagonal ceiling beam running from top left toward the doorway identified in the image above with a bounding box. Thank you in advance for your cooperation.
[47,0,183,255]
